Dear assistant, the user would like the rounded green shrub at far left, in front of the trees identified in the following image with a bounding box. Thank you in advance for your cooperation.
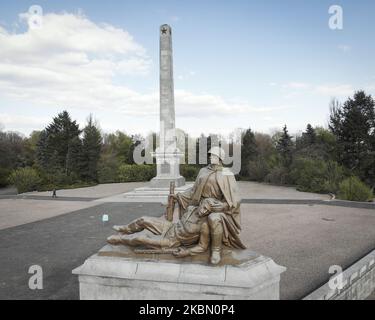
[9,167,41,193]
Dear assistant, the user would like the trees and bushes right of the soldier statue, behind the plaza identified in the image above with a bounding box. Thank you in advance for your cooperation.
[240,91,375,200]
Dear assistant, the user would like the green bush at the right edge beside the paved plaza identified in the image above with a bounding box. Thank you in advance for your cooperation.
[338,176,374,201]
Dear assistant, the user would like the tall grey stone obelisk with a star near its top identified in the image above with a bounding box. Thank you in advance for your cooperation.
[151,24,185,188]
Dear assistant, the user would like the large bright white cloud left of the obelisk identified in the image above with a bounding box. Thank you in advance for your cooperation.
[0,13,155,114]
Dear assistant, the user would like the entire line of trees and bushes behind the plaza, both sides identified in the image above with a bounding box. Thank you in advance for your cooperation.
[0,91,375,200]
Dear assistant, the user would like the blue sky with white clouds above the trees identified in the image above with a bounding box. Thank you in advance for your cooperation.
[0,0,375,136]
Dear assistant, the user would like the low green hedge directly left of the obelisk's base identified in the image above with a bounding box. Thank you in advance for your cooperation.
[118,164,156,182]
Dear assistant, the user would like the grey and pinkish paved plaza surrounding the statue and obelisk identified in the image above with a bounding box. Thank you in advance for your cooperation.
[0,182,375,299]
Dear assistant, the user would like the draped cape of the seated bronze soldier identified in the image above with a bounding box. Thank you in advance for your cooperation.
[177,165,246,249]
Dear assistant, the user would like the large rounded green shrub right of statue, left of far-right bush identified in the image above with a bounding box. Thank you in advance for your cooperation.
[291,158,344,193]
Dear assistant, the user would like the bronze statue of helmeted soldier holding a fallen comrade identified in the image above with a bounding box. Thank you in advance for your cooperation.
[107,147,246,264]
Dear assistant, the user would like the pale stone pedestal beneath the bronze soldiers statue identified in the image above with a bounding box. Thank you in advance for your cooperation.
[73,245,286,300]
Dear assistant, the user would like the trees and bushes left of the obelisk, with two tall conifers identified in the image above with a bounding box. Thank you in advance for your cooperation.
[0,111,145,192]
